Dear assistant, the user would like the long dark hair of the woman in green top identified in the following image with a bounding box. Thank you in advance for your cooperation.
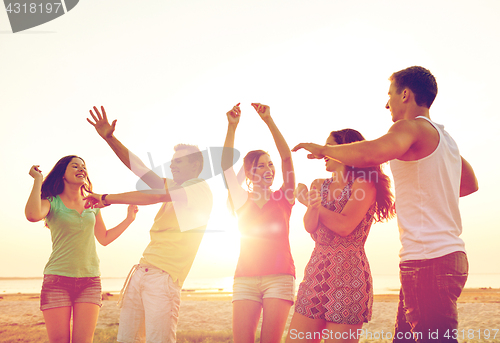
[42,155,92,199]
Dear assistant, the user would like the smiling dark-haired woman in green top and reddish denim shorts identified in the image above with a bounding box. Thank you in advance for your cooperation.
[25,155,137,342]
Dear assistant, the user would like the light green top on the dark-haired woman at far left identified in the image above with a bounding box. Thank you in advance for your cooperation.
[43,195,101,277]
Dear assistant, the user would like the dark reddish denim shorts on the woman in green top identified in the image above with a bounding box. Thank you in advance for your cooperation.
[40,274,102,311]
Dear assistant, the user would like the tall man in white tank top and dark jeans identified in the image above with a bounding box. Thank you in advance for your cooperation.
[293,67,478,342]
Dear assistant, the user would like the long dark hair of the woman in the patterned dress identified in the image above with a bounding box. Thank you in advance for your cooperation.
[330,129,395,222]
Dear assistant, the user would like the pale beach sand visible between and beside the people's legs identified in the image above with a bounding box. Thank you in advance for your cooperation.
[0,288,500,342]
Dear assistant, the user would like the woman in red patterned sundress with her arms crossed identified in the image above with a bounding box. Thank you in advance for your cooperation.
[287,129,394,342]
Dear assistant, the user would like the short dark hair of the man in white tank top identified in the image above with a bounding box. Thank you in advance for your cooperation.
[389,66,437,108]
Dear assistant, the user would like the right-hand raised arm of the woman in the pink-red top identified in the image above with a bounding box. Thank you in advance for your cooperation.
[252,103,295,202]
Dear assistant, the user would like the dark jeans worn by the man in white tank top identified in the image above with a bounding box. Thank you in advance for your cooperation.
[393,251,469,343]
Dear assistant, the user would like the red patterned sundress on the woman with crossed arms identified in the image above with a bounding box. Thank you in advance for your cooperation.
[295,179,375,325]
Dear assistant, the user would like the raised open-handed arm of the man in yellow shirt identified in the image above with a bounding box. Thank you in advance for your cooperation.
[87,106,164,189]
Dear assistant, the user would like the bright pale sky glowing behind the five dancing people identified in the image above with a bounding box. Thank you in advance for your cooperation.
[0,0,500,287]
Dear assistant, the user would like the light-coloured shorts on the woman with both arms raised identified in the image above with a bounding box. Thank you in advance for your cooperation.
[233,274,295,304]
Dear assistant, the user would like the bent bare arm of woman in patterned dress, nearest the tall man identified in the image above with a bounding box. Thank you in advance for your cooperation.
[319,179,377,237]
